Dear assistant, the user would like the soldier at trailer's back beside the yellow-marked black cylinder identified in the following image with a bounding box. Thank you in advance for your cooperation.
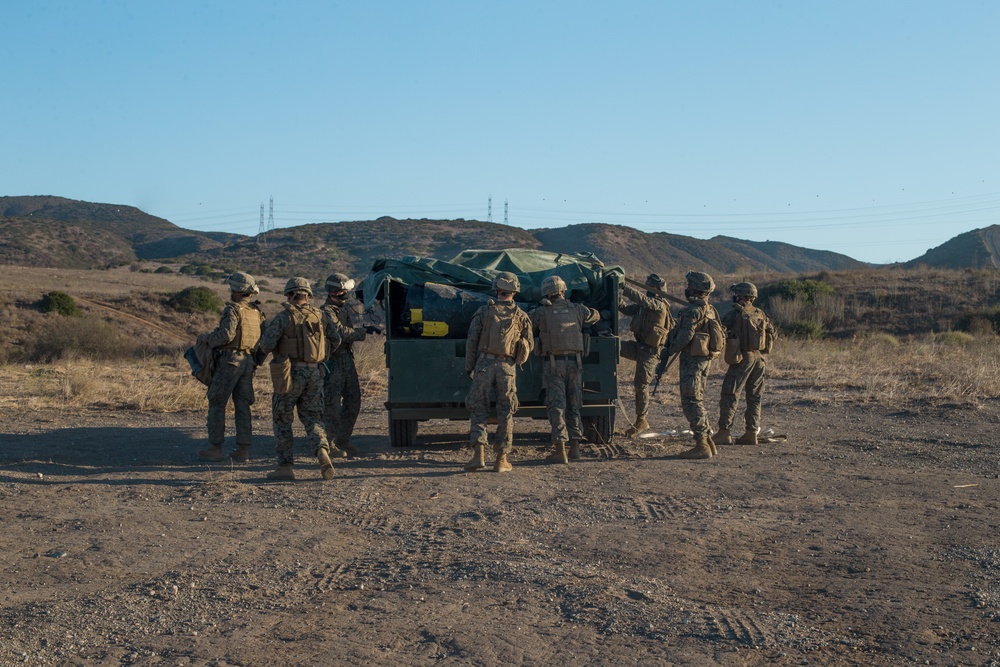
[465,271,532,472]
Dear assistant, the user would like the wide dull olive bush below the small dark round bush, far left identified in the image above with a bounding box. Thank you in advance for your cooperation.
[24,317,134,363]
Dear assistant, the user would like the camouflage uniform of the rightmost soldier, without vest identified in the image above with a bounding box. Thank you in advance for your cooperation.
[719,303,774,433]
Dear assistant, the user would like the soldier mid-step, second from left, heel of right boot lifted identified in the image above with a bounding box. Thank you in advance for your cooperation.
[255,278,340,480]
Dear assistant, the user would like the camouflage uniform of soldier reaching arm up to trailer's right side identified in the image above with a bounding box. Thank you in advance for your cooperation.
[618,284,672,424]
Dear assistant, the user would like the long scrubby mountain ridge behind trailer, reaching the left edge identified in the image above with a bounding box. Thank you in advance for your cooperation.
[0,196,892,276]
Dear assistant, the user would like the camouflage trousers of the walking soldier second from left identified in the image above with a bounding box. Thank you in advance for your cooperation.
[271,364,329,466]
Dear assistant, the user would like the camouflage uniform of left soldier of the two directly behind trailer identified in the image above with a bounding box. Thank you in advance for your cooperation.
[465,301,532,456]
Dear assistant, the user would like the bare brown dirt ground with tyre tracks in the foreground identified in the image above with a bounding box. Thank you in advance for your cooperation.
[0,374,1000,666]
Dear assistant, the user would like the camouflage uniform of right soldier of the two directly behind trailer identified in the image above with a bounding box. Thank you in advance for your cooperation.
[531,298,601,444]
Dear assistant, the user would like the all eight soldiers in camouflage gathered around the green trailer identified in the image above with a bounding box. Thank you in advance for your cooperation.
[198,271,775,480]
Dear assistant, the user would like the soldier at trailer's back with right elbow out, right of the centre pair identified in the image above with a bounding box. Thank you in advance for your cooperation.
[531,276,601,463]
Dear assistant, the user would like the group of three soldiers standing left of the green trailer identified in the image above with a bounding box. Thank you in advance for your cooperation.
[198,272,378,480]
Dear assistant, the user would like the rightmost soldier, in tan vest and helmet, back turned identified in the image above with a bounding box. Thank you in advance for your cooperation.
[713,282,774,445]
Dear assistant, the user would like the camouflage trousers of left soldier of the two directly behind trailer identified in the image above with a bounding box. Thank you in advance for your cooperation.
[465,356,518,456]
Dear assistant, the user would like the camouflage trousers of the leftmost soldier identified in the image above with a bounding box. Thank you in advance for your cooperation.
[208,351,256,445]
